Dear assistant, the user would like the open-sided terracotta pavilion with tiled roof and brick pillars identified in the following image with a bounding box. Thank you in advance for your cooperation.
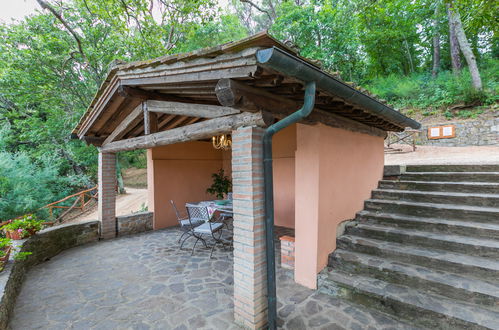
[74,33,419,329]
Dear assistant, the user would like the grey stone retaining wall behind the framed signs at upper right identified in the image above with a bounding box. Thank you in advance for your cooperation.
[416,116,499,147]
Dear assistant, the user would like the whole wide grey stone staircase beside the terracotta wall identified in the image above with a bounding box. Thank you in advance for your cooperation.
[319,165,499,329]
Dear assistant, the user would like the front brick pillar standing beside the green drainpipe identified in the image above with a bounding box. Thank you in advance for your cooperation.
[232,127,267,329]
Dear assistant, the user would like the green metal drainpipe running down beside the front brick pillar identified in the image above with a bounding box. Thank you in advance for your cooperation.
[263,81,315,330]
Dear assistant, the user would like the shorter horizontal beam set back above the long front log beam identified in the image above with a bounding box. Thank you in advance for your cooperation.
[146,100,240,118]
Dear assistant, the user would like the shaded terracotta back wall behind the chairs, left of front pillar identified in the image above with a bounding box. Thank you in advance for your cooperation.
[147,142,224,229]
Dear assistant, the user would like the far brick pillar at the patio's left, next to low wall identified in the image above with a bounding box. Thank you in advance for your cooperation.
[99,152,116,238]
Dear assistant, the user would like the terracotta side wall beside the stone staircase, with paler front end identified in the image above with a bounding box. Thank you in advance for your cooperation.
[295,125,384,288]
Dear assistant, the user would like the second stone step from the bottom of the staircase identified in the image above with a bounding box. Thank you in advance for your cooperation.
[329,250,499,311]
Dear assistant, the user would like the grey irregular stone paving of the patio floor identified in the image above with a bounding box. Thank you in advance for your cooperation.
[10,229,418,330]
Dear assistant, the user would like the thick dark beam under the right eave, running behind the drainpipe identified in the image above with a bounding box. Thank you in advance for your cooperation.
[215,79,387,138]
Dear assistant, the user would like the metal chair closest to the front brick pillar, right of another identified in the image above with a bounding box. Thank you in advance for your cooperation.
[185,204,225,258]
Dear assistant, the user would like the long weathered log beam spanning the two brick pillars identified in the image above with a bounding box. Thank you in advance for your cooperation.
[100,112,273,152]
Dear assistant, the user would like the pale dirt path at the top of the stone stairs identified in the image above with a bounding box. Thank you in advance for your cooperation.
[385,145,499,165]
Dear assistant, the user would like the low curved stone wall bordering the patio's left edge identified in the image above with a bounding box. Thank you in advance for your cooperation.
[0,221,99,329]
